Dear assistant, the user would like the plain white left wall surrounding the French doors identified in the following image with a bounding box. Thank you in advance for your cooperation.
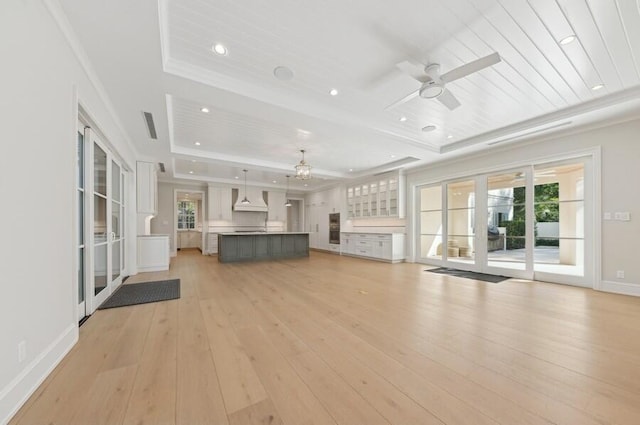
[0,0,135,423]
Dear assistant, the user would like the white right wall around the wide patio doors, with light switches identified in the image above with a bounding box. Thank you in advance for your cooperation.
[407,117,640,295]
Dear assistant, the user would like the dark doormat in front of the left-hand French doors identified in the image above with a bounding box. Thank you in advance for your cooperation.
[98,279,180,310]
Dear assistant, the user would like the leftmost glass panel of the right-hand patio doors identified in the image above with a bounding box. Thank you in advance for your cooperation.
[420,185,442,260]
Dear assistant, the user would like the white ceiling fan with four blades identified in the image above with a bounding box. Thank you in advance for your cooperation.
[385,52,501,110]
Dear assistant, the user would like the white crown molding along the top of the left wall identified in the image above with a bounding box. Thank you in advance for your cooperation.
[43,0,139,162]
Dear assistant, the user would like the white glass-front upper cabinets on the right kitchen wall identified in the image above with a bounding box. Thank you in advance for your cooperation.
[347,172,405,218]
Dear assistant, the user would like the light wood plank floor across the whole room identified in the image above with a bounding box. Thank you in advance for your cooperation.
[11,251,640,425]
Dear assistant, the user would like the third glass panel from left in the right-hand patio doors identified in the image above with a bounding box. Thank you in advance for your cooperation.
[487,172,527,270]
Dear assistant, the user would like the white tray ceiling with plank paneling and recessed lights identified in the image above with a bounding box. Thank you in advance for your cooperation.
[60,0,640,190]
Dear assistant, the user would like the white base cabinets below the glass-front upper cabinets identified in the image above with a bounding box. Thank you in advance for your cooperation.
[340,232,404,263]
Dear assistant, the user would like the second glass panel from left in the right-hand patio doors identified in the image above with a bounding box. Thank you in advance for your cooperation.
[443,180,475,264]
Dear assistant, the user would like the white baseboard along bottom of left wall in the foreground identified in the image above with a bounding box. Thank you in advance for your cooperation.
[0,323,79,424]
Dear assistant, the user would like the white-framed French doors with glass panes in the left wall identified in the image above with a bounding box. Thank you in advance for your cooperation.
[77,123,126,319]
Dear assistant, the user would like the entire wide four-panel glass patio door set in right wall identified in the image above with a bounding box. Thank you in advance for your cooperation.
[416,157,595,286]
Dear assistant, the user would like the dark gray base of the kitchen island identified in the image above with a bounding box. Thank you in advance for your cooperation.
[218,232,309,263]
